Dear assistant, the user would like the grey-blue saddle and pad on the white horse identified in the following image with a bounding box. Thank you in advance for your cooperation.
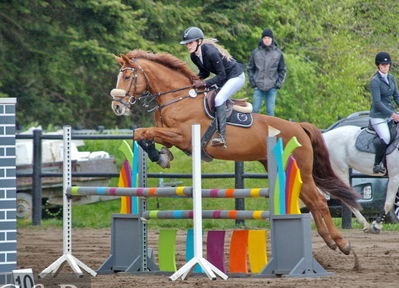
[355,121,399,155]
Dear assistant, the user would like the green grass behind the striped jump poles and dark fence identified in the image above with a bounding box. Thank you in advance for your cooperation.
[17,140,399,231]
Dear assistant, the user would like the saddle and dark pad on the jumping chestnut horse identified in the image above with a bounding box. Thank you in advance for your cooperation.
[204,89,253,128]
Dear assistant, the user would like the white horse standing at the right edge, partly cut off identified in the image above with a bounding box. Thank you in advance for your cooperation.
[323,119,399,233]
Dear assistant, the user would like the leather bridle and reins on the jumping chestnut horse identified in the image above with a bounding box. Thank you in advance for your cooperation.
[111,58,197,112]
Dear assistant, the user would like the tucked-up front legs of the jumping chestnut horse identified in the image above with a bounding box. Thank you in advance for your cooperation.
[134,127,182,168]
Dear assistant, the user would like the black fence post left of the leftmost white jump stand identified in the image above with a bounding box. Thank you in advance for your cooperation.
[32,129,42,225]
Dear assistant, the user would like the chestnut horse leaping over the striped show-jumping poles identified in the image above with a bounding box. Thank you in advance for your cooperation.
[111,50,360,255]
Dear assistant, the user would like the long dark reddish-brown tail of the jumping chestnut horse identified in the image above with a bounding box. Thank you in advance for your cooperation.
[299,122,361,210]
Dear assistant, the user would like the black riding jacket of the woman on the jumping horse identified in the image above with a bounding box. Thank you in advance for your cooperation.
[190,44,244,87]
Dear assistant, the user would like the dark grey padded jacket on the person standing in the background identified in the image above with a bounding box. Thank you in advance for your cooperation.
[248,40,286,91]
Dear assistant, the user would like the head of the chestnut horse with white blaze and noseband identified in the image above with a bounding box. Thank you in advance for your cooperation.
[111,55,149,116]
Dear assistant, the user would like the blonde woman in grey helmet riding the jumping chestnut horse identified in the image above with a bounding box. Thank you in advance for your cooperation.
[180,27,245,147]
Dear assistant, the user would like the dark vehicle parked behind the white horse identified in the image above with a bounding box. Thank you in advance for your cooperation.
[322,111,399,223]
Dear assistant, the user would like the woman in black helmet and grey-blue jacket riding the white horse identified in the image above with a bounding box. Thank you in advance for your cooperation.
[370,52,399,174]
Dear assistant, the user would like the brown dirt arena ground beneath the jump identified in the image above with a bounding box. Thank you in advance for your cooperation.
[17,227,399,288]
